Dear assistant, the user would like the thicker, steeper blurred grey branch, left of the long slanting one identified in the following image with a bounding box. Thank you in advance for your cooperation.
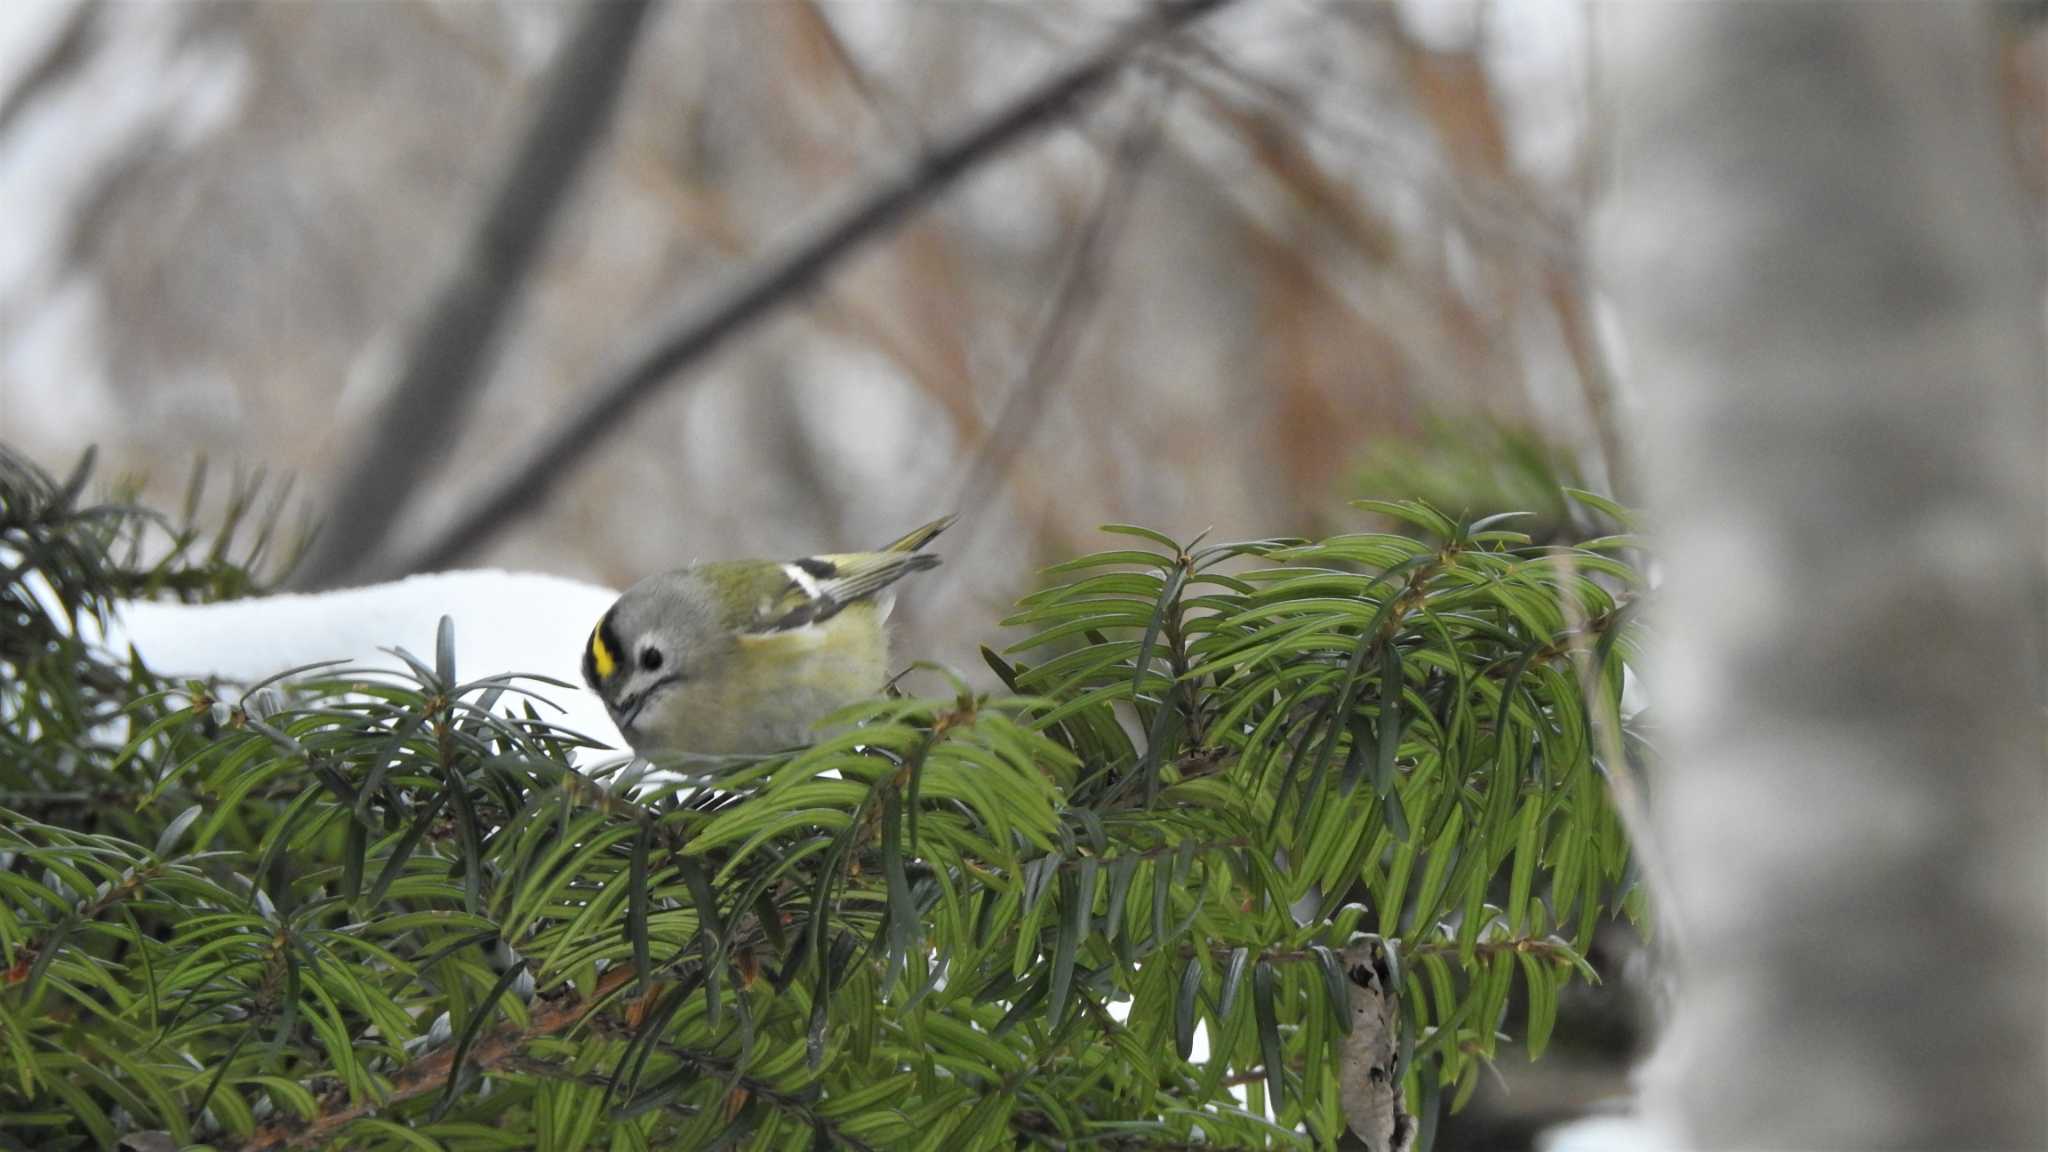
[297,0,649,586]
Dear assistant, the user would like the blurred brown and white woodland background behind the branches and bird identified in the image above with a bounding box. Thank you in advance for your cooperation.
[0,0,2048,1148]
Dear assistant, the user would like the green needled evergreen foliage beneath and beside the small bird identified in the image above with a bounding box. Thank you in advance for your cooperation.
[0,448,1636,1150]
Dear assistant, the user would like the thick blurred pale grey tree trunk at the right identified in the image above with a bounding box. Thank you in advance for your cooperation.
[1595,4,2048,1148]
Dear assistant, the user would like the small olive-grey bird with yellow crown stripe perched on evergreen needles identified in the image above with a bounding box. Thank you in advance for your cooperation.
[584,517,952,756]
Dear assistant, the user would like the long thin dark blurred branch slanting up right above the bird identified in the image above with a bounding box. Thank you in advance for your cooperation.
[371,0,1233,576]
